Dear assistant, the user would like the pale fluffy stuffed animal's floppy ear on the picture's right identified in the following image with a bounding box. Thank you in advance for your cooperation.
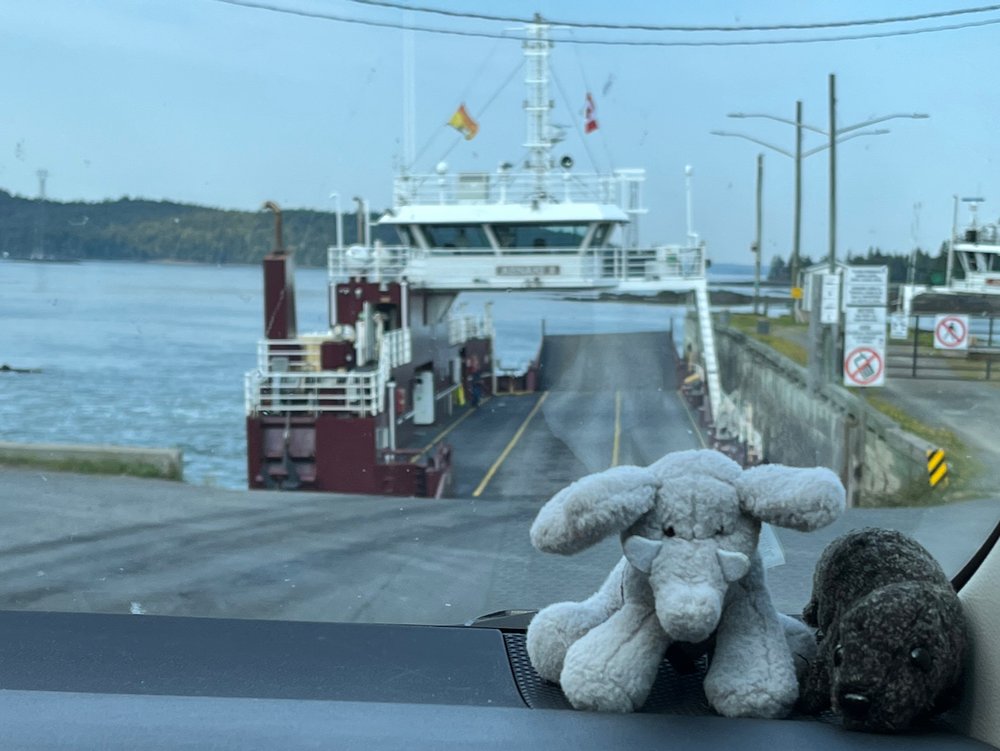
[736,464,845,532]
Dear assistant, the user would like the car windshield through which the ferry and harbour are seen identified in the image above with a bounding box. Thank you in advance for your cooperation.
[0,0,1000,623]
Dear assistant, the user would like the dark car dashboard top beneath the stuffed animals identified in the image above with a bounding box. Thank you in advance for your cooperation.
[0,612,989,751]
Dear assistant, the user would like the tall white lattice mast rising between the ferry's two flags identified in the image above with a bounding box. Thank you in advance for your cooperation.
[524,13,552,201]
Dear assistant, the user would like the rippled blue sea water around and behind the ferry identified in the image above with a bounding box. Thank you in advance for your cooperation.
[0,261,752,488]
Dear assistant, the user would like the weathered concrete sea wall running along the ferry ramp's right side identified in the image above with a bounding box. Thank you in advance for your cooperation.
[715,326,930,506]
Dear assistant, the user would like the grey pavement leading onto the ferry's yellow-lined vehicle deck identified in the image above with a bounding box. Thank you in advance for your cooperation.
[0,334,1000,623]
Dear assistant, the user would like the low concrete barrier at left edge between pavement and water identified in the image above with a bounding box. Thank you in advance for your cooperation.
[0,441,184,480]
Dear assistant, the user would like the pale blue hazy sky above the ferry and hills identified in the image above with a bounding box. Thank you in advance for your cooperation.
[0,0,1000,262]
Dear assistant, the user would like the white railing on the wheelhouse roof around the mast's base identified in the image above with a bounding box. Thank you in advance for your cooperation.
[393,170,644,206]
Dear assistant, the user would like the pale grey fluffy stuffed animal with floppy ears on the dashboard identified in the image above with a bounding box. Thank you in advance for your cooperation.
[527,450,844,717]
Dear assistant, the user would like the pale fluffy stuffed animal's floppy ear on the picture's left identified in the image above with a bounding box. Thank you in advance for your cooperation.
[531,467,660,555]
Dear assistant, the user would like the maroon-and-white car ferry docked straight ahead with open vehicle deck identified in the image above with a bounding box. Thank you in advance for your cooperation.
[245,16,719,496]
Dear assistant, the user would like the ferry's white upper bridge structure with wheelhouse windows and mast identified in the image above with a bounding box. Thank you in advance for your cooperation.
[332,17,705,291]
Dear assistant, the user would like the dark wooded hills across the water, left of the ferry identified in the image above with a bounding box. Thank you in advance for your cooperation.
[0,190,390,266]
